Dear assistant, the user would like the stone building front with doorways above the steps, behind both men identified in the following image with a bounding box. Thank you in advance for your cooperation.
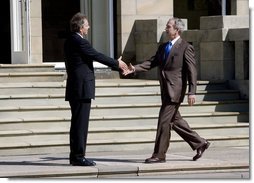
[0,0,249,97]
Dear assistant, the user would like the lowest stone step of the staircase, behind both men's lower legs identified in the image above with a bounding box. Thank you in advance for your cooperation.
[0,135,250,156]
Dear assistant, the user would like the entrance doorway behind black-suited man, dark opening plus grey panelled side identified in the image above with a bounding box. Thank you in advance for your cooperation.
[42,0,116,67]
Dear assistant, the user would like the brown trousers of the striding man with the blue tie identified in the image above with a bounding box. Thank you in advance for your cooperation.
[153,102,205,158]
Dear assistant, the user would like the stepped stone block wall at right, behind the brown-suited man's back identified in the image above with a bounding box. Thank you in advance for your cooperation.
[183,15,249,99]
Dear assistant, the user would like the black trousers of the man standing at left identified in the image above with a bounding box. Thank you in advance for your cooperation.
[69,99,91,158]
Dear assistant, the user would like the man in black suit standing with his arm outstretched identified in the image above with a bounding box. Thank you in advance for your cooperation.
[64,13,128,166]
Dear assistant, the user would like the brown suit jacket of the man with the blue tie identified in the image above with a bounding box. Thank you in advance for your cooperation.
[135,38,197,103]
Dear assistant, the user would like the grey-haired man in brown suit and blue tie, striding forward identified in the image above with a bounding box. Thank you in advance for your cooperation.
[125,18,210,163]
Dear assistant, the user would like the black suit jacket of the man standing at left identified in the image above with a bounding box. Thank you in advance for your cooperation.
[64,33,119,101]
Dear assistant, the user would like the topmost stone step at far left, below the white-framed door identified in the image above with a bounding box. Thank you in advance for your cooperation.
[0,64,55,73]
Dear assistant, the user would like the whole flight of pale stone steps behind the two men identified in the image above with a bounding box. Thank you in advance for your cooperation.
[0,65,249,155]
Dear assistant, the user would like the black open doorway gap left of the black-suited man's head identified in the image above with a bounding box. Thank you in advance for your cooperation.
[42,0,80,62]
